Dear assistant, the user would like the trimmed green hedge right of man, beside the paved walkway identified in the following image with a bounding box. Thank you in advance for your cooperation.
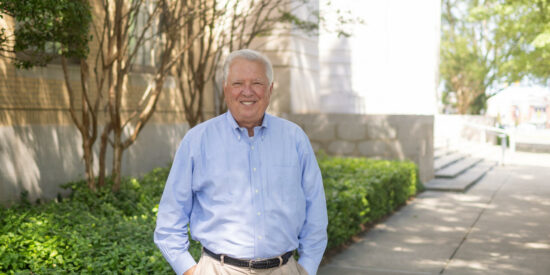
[319,156,422,249]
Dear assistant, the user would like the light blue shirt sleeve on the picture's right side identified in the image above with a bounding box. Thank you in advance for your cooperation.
[298,133,328,275]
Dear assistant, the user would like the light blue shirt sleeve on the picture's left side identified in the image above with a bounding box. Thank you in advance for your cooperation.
[154,138,196,275]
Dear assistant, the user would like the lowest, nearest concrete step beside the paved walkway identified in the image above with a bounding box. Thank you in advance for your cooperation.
[424,161,497,192]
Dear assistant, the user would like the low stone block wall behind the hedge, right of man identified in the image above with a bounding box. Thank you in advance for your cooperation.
[285,114,434,187]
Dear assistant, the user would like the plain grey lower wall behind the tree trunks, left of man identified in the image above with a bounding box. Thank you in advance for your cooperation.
[0,123,189,205]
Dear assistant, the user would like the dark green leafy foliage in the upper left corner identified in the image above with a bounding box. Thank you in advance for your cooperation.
[0,0,92,68]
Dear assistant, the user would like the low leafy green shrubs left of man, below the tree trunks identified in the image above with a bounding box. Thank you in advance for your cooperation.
[0,169,200,274]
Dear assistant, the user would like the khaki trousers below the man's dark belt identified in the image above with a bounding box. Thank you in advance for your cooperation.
[193,253,308,275]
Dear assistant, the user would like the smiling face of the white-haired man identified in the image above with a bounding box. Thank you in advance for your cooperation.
[223,58,273,129]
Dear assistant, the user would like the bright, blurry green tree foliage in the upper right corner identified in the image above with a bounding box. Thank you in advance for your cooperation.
[439,0,550,114]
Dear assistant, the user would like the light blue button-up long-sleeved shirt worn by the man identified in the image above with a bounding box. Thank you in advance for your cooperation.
[154,112,328,275]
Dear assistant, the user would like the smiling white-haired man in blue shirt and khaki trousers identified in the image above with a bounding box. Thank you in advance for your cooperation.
[155,49,327,275]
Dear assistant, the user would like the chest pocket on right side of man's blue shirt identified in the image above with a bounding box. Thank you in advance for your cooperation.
[268,165,302,205]
